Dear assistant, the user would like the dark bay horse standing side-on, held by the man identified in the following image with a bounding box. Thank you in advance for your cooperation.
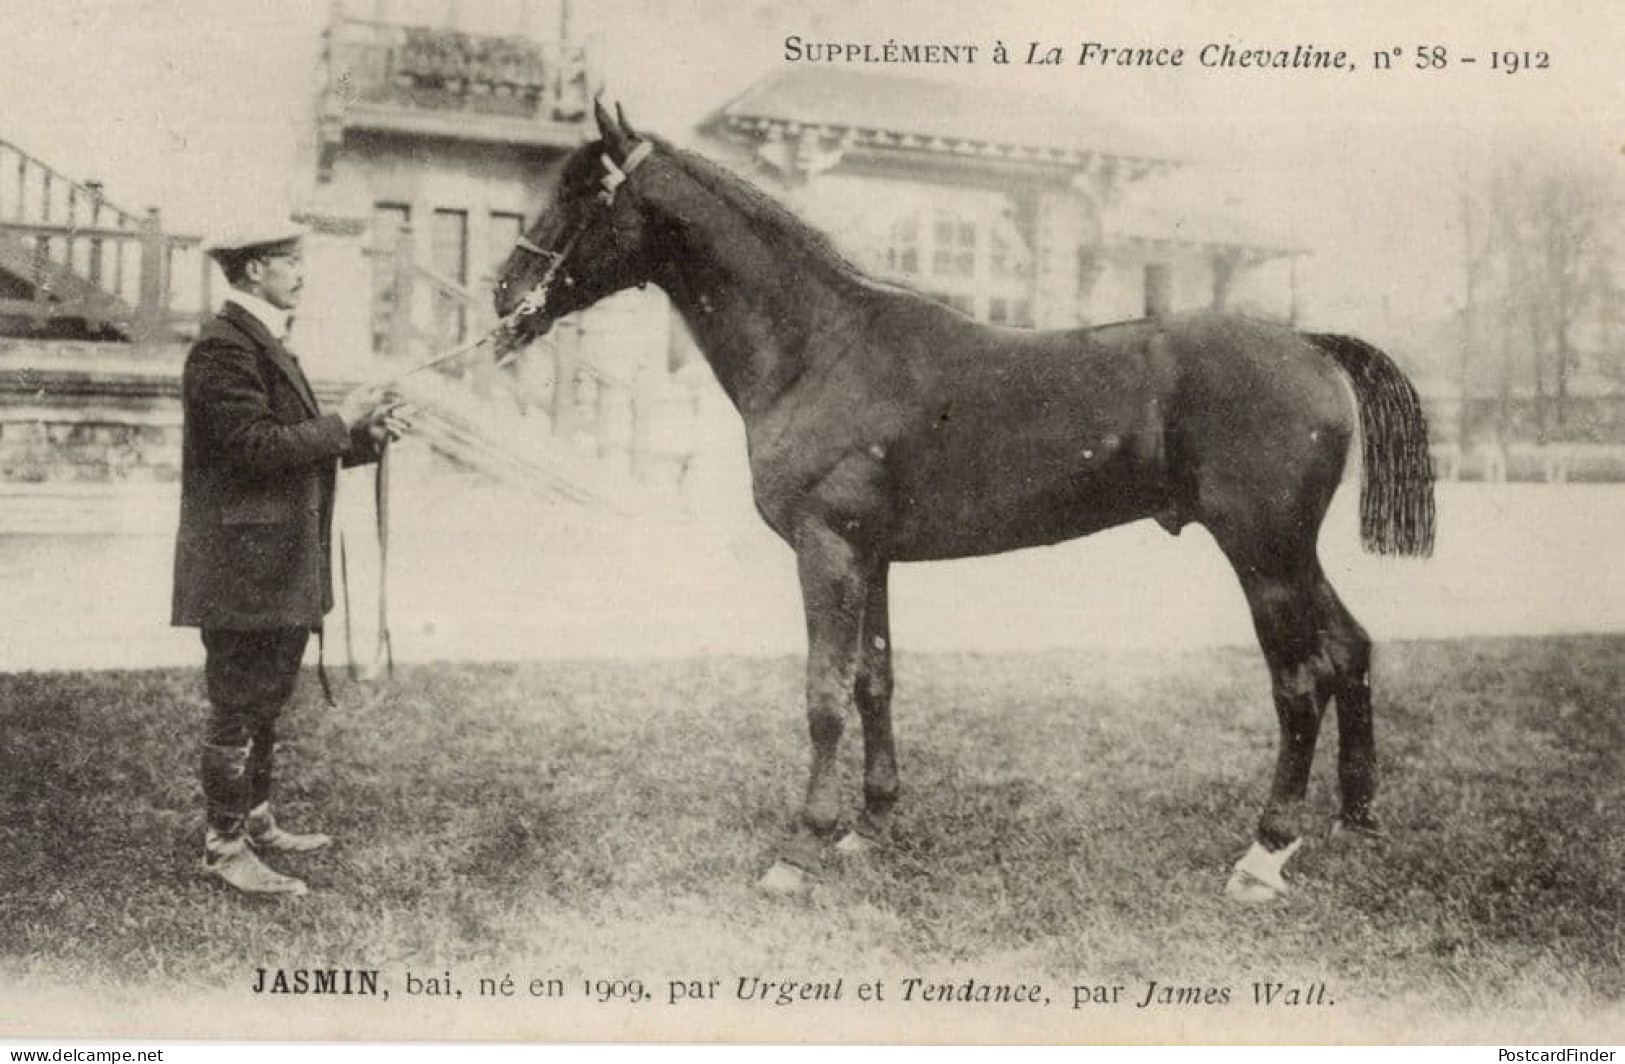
[496,104,1433,900]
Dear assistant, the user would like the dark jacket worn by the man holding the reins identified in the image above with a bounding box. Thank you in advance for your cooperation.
[171,304,377,629]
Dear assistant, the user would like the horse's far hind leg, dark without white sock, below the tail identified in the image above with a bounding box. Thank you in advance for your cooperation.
[1315,572,1378,835]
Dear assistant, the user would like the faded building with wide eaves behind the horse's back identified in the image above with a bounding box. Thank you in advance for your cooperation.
[700,67,1302,328]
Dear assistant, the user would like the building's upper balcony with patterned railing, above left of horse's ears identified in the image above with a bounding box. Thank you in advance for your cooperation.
[319,15,592,179]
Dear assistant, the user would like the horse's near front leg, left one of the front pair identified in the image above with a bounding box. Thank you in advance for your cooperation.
[762,521,869,892]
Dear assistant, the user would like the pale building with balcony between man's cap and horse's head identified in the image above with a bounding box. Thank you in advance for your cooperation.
[309,0,590,362]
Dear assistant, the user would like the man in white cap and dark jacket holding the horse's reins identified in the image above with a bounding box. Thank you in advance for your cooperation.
[171,226,405,893]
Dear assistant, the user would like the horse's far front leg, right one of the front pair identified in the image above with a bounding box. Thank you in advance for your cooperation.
[837,564,899,854]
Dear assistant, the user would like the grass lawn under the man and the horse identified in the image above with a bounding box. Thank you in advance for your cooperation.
[0,637,1625,1041]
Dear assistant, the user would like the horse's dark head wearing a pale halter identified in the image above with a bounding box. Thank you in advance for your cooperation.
[496,102,653,341]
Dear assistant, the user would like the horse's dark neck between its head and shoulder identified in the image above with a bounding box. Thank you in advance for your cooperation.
[646,183,847,419]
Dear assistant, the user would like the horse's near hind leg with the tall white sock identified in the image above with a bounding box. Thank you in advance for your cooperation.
[1225,572,1331,902]
